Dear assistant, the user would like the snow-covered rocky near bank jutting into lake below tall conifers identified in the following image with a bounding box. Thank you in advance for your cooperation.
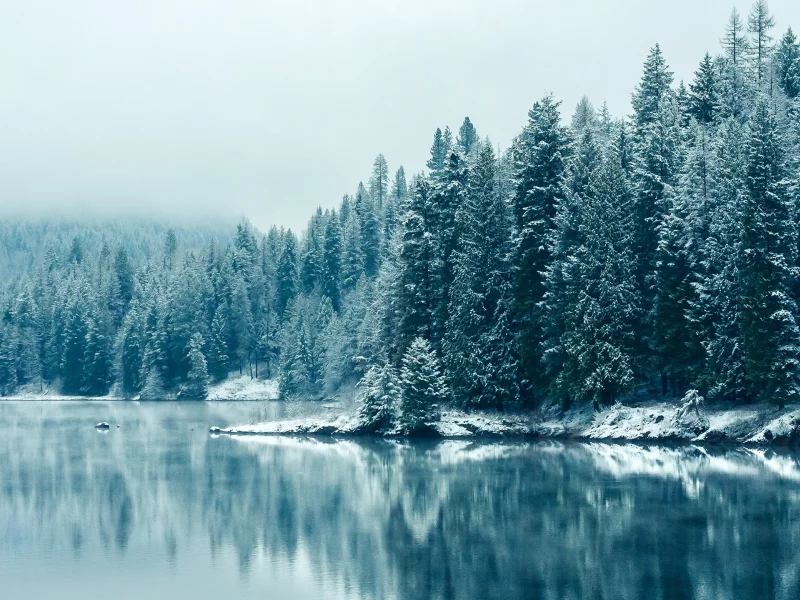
[219,402,800,446]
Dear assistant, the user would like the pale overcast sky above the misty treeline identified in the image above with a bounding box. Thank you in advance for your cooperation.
[0,0,800,229]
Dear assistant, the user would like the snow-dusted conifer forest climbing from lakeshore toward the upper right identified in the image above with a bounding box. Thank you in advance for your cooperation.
[0,1,800,430]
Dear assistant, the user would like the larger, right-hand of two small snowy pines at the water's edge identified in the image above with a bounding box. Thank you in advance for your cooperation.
[398,337,450,435]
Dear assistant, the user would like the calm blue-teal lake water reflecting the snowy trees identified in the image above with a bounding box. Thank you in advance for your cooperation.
[0,402,800,600]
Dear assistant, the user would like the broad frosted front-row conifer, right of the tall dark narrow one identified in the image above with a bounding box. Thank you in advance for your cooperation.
[545,144,640,406]
